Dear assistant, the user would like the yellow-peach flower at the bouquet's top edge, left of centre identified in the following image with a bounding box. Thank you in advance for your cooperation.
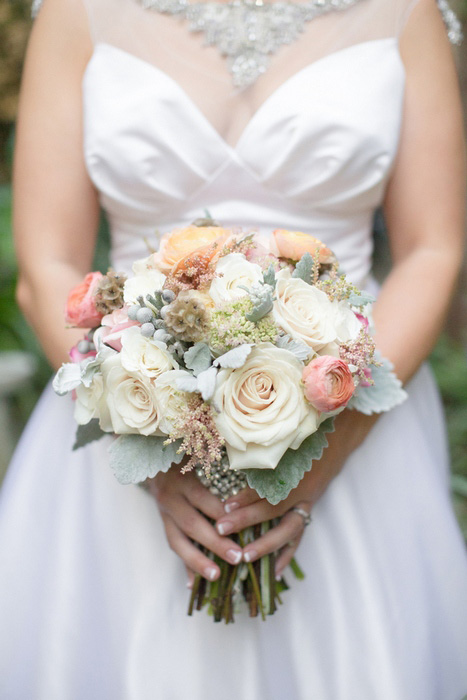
[153,226,231,274]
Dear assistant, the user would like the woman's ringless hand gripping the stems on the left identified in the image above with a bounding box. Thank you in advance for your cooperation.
[146,465,242,585]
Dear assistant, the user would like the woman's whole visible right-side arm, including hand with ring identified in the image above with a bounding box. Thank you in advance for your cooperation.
[202,0,465,573]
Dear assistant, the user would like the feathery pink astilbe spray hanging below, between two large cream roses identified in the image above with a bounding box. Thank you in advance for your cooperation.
[167,396,225,476]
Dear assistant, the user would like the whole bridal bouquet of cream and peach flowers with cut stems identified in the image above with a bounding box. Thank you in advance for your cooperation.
[54,219,405,622]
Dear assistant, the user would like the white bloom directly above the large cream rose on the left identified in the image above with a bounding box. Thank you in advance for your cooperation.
[121,326,178,379]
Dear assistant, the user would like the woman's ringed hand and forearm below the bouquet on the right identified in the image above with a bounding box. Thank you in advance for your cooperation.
[216,411,375,576]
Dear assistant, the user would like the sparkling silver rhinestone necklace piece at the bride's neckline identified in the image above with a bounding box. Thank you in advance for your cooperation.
[137,0,368,88]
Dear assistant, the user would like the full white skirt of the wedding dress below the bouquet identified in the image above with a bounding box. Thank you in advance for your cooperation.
[0,367,467,700]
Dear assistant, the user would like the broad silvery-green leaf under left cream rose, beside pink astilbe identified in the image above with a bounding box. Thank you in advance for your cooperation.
[109,435,183,484]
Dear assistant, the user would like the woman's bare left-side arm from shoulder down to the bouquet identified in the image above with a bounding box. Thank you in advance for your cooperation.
[13,0,99,367]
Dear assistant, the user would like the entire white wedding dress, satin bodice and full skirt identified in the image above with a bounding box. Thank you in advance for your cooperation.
[0,0,467,700]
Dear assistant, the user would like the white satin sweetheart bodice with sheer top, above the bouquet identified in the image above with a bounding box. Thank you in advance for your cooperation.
[83,0,414,284]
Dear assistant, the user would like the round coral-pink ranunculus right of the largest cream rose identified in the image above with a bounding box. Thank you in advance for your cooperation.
[302,355,355,413]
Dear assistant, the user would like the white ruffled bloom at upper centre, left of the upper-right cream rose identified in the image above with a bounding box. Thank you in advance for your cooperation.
[209,253,263,304]
